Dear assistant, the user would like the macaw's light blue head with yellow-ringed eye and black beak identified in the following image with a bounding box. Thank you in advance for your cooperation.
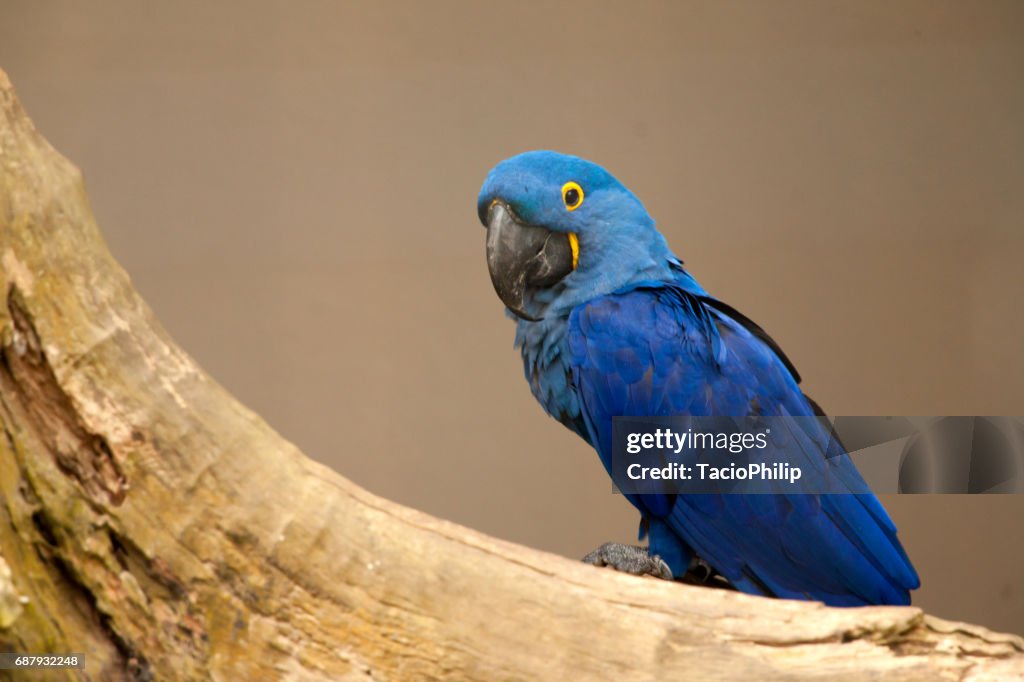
[477,152,679,322]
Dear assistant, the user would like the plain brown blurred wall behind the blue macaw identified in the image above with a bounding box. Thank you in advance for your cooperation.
[0,0,1024,632]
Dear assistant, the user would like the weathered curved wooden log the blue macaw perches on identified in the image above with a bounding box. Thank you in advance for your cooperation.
[0,72,1024,680]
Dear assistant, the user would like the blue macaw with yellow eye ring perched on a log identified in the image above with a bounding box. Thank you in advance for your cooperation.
[477,152,920,606]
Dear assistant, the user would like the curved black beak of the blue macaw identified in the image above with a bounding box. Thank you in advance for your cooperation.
[486,201,572,322]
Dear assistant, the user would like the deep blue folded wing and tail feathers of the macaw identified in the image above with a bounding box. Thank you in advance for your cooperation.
[567,283,919,605]
